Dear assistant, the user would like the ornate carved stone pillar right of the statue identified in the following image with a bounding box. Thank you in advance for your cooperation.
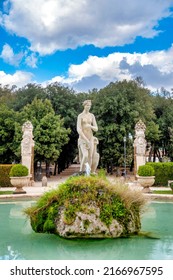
[134,120,147,174]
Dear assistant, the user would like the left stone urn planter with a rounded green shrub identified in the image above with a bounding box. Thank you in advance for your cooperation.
[9,164,29,194]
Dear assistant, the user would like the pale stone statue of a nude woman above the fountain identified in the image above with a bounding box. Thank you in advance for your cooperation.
[77,100,99,173]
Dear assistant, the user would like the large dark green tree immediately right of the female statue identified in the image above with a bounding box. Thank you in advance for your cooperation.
[93,80,155,169]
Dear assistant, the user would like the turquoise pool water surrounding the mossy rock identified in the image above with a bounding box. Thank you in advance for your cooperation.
[0,201,173,260]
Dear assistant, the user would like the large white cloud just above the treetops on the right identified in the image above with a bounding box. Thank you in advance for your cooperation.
[44,46,173,90]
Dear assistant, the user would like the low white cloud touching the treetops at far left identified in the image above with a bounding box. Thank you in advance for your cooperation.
[0,71,33,87]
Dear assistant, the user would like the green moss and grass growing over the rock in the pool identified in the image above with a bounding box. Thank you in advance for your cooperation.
[25,176,144,234]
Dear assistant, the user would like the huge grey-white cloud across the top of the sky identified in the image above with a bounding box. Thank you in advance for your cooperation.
[1,0,173,55]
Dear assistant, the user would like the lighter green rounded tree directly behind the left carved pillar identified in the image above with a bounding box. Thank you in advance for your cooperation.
[15,98,70,174]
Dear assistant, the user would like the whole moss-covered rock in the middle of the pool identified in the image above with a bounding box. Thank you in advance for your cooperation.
[25,176,145,238]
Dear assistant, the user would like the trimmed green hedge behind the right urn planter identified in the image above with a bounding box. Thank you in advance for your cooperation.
[147,162,173,186]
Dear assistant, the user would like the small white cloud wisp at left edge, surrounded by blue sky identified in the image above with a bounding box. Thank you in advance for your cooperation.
[0,44,23,66]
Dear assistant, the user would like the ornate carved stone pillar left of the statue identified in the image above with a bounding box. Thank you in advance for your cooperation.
[21,121,34,184]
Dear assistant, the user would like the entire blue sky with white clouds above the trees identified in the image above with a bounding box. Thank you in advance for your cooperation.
[0,0,173,91]
